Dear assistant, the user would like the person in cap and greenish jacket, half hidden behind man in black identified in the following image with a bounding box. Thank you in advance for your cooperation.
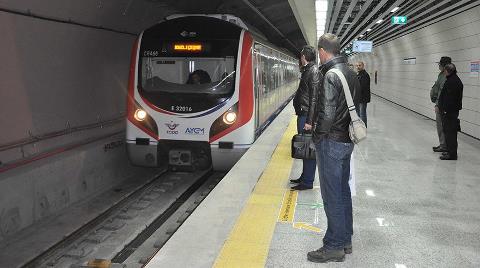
[430,57,452,152]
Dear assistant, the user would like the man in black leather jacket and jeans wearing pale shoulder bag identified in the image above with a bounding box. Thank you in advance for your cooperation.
[306,33,360,262]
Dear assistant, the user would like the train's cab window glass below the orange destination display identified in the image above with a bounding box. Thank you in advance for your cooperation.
[139,57,235,113]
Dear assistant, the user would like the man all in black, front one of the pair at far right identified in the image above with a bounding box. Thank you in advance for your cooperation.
[438,63,463,160]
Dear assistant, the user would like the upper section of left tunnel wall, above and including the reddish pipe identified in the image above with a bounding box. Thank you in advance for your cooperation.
[0,9,135,163]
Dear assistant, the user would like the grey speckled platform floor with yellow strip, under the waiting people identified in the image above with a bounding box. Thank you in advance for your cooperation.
[147,97,480,268]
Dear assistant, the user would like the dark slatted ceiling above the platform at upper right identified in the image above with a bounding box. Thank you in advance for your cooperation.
[325,0,480,51]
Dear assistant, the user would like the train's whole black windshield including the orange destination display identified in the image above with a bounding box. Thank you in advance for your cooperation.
[138,37,238,113]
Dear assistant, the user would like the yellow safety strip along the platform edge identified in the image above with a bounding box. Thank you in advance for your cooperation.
[214,119,296,268]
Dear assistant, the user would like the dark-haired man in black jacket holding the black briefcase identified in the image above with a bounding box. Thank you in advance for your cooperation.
[290,46,319,190]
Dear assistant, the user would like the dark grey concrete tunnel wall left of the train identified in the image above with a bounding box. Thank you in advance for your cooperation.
[0,0,171,242]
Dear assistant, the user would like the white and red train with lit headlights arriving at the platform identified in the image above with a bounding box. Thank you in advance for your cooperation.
[126,14,299,170]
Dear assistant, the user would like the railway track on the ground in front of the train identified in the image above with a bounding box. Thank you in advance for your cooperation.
[22,171,224,268]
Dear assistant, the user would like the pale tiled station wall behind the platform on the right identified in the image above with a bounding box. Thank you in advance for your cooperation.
[349,7,480,138]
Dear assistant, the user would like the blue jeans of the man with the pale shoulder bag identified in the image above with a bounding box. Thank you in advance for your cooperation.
[315,138,354,249]
